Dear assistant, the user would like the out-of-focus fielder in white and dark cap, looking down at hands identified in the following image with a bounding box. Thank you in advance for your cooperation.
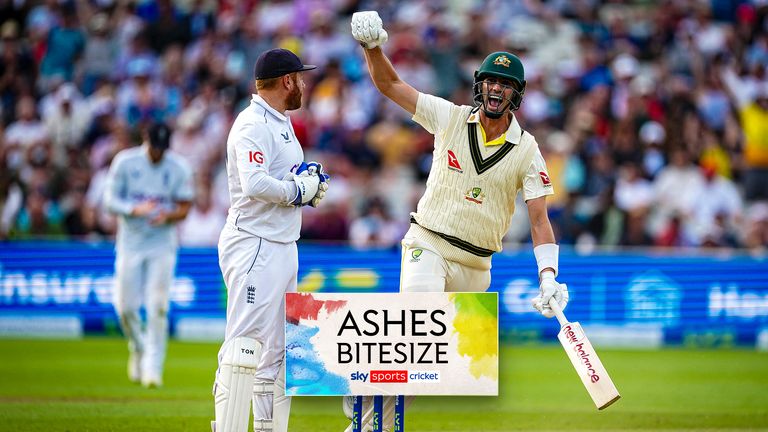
[105,123,194,387]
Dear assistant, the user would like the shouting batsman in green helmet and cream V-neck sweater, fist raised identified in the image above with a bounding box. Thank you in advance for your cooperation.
[344,11,568,428]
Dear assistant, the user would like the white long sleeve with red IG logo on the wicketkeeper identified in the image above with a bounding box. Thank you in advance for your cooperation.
[235,124,297,204]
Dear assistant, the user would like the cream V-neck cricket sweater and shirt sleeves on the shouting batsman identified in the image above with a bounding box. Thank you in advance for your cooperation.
[412,93,553,256]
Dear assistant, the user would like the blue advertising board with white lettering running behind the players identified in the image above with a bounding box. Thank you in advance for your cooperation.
[0,242,768,345]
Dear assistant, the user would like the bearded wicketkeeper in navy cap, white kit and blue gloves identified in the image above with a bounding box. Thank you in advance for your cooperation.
[211,49,328,432]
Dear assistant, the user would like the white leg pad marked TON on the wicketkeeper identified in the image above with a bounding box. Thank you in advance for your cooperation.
[212,337,261,432]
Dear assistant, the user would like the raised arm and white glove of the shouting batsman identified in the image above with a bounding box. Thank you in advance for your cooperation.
[352,11,419,114]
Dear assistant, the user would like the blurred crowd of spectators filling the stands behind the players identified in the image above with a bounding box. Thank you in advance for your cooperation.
[0,0,768,253]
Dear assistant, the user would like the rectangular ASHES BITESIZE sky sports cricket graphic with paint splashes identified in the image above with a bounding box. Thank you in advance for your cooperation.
[285,293,499,396]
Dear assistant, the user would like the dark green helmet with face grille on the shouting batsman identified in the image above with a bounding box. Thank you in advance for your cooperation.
[472,51,525,118]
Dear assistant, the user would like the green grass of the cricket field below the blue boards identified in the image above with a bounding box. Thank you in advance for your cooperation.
[0,338,768,432]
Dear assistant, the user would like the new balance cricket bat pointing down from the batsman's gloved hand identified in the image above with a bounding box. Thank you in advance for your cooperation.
[549,292,621,410]
